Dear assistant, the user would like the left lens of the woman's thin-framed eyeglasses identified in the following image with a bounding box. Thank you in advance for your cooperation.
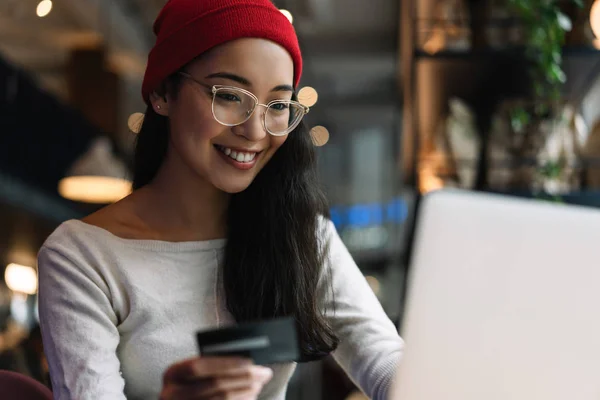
[213,88,256,126]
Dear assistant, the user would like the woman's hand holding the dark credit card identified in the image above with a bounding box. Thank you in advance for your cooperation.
[160,357,273,400]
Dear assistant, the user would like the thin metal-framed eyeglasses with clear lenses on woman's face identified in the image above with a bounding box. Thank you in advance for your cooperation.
[179,72,310,136]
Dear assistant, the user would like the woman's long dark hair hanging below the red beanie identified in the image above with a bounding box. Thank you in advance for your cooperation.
[133,74,339,361]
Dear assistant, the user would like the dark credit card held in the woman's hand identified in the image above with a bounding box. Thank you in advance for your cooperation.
[196,317,300,365]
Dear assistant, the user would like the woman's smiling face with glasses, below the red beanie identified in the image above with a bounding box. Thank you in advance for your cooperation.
[144,38,306,194]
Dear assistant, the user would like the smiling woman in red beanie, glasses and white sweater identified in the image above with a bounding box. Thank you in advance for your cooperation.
[39,0,402,400]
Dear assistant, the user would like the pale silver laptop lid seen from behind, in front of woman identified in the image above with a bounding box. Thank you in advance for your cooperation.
[389,190,600,400]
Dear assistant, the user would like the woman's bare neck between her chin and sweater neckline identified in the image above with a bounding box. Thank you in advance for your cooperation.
[140,147,230,240]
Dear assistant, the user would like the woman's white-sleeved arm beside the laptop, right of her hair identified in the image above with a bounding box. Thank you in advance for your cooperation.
[325,221,404,400]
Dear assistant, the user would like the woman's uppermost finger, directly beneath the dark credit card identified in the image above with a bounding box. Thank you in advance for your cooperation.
[163,357,252,383]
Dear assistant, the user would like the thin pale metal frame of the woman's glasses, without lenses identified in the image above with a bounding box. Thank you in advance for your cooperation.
[179,71,310,136]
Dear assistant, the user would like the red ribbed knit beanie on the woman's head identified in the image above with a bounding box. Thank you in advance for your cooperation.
[142,0,302,103]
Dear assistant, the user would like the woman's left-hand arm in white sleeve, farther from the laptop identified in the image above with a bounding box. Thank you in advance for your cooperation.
[38,246,125,400]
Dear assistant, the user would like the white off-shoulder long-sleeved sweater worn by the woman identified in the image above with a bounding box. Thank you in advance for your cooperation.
[38,220,403,400]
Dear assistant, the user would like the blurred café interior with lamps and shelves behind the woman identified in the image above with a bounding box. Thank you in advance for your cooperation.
[0,0,600,400]
